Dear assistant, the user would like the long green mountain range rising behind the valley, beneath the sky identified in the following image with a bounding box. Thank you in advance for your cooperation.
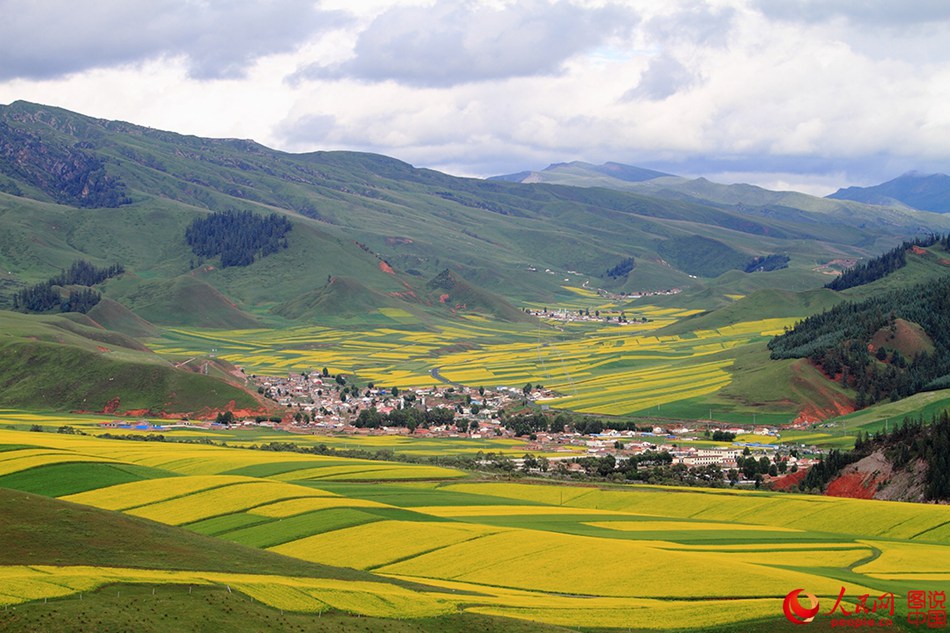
[0,102,950,310]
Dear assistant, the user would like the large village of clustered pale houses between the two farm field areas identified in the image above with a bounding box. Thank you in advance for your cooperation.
[238,370,815,483]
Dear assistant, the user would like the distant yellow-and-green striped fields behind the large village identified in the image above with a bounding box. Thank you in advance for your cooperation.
[150,297,795,415]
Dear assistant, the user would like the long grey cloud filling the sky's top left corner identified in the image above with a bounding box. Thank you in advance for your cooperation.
[0,0,345,79]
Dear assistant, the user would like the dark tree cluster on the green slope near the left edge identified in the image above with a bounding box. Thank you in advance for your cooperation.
[13,259,125,314]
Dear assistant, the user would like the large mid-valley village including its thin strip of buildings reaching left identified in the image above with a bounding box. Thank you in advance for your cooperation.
[95,370,821,486]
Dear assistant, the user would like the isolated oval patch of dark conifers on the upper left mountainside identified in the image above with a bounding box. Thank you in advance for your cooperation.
[185,209,293,268]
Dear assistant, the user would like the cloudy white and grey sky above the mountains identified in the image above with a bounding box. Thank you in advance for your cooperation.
[0,0,950,195]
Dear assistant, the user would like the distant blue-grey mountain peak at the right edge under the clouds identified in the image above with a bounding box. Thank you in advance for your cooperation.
[828,172,950,213]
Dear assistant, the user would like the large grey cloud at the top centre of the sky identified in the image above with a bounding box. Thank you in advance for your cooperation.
[300,0,637,87]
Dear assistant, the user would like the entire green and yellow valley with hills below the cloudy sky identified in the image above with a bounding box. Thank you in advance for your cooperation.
[0,102,950,633]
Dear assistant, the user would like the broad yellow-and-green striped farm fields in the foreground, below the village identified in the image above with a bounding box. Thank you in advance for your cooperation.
[0,430,950,630]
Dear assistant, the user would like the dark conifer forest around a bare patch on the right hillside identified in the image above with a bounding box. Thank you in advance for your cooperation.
[769,277,950,408]
